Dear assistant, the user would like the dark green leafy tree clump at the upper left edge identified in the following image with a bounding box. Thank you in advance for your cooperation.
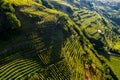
[0,0,21,39]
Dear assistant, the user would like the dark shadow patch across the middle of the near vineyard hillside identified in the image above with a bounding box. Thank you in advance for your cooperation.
[34,16,71,66]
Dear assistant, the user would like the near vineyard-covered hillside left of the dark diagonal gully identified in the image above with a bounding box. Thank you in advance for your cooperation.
[0,0,119,80]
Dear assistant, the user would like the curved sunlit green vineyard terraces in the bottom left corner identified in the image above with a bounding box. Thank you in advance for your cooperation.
[0,59,41,80]
